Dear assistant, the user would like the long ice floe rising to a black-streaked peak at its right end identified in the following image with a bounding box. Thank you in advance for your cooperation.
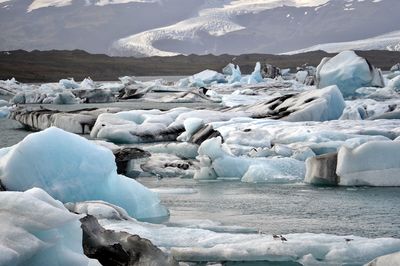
[91,86,345,143]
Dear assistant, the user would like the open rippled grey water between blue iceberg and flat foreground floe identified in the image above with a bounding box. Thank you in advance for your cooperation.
[139,178,400,238]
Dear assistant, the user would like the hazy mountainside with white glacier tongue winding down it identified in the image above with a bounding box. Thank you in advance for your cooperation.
[0,0,400,56]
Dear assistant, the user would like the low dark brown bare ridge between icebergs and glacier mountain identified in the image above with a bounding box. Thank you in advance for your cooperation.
[0,50,400,82]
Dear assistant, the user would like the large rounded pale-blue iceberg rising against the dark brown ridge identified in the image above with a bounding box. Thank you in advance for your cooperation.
[316,51,385,97]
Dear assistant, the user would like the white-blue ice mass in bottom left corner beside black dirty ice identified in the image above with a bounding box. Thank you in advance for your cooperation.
[0,188,93,266]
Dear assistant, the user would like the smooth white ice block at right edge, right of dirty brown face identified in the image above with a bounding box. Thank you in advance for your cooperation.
[336,141,400,186]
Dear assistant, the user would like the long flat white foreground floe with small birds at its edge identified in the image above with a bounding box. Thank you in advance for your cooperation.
[99,215,400,265]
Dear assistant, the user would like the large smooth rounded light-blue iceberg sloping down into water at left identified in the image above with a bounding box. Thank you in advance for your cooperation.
[0,127,168,219]
